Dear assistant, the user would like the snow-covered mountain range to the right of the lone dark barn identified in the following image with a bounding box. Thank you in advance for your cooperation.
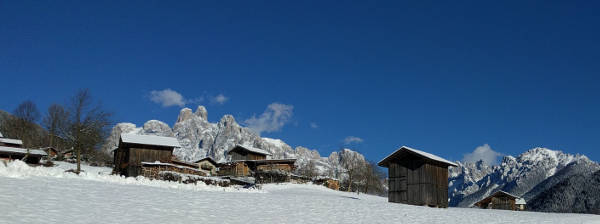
[448,148,600,207]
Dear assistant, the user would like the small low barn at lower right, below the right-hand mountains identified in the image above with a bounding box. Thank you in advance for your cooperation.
[475,191,525,211]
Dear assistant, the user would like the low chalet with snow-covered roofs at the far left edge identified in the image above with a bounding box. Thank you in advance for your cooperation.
[0,138,47,164]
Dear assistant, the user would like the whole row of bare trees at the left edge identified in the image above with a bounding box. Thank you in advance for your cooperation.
[0,89,113,173]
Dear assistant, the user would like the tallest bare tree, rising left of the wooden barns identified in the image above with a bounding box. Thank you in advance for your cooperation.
[65,89,112,173]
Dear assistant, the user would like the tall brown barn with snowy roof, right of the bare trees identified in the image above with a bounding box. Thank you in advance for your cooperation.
[113,134,181,177]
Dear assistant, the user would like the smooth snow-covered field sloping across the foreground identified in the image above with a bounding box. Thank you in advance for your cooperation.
[0,162,600,224]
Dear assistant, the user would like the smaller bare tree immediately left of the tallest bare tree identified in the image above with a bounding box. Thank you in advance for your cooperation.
[42,104,69,150]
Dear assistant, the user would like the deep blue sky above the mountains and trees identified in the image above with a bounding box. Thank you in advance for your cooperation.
[0,1,600,164]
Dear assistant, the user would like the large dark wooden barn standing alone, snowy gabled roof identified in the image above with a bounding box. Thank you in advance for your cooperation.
[377,146,457,208]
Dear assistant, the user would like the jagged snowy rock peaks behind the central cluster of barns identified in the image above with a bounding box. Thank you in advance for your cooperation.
[103,106,365,177]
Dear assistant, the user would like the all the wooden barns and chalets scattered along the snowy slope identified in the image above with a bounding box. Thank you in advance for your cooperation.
[0,133,526,211]
